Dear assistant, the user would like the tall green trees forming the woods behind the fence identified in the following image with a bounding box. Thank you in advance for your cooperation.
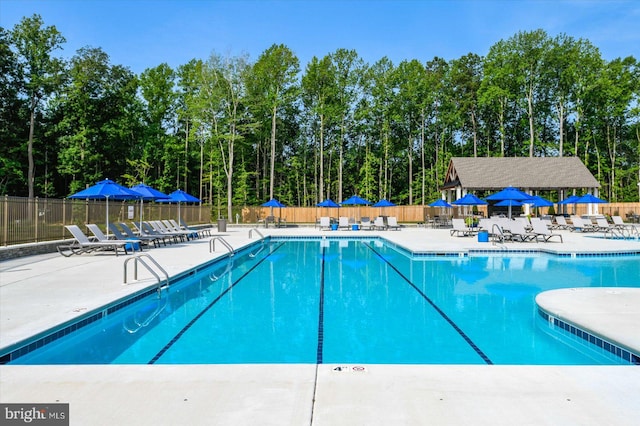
[0,15,640,208]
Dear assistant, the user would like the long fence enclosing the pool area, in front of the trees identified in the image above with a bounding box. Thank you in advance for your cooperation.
[0,196,640,246]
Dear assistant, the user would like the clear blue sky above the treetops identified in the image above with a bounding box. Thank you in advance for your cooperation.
[0,0,640,73]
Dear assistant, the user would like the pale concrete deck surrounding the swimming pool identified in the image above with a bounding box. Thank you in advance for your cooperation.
[0,227,640,425]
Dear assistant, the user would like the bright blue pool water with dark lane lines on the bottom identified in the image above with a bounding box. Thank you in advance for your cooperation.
[12,239,640,365]
